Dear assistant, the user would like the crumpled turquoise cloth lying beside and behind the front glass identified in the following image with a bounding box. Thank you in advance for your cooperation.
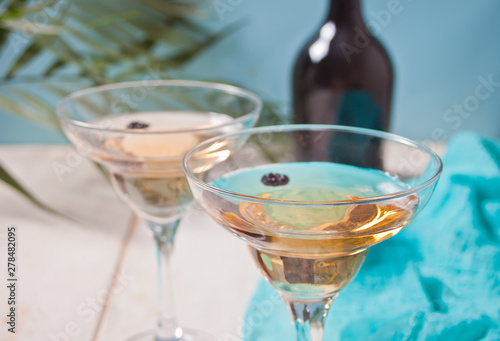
[240,133,500,341]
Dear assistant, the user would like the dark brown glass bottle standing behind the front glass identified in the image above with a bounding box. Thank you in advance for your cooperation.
[293,0,393,166]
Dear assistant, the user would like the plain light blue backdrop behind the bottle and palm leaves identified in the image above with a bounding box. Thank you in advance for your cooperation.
[0,0,500,143]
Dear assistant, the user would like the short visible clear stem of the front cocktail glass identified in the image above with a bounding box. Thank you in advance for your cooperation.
[282,295,336,341]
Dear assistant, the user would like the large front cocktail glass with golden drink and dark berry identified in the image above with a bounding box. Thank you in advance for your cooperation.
[183,125,442,341]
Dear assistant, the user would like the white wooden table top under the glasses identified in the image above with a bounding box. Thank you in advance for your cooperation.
[0,145,259,341]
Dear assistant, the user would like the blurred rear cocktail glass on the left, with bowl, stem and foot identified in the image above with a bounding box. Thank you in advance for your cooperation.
[57,80,262,341]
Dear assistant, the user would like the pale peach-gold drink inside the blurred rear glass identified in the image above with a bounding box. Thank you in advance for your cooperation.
[92,112,238,220]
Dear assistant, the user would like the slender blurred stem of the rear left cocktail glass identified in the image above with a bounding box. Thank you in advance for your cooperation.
[148,218,182,341]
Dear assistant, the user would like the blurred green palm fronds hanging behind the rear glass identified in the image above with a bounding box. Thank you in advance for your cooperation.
[0,0,246,216]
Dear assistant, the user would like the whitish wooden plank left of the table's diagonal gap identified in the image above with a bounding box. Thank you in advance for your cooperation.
[0,146,130,341]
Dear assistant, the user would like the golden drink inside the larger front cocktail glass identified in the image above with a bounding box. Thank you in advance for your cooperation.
[209,165,418,299]
